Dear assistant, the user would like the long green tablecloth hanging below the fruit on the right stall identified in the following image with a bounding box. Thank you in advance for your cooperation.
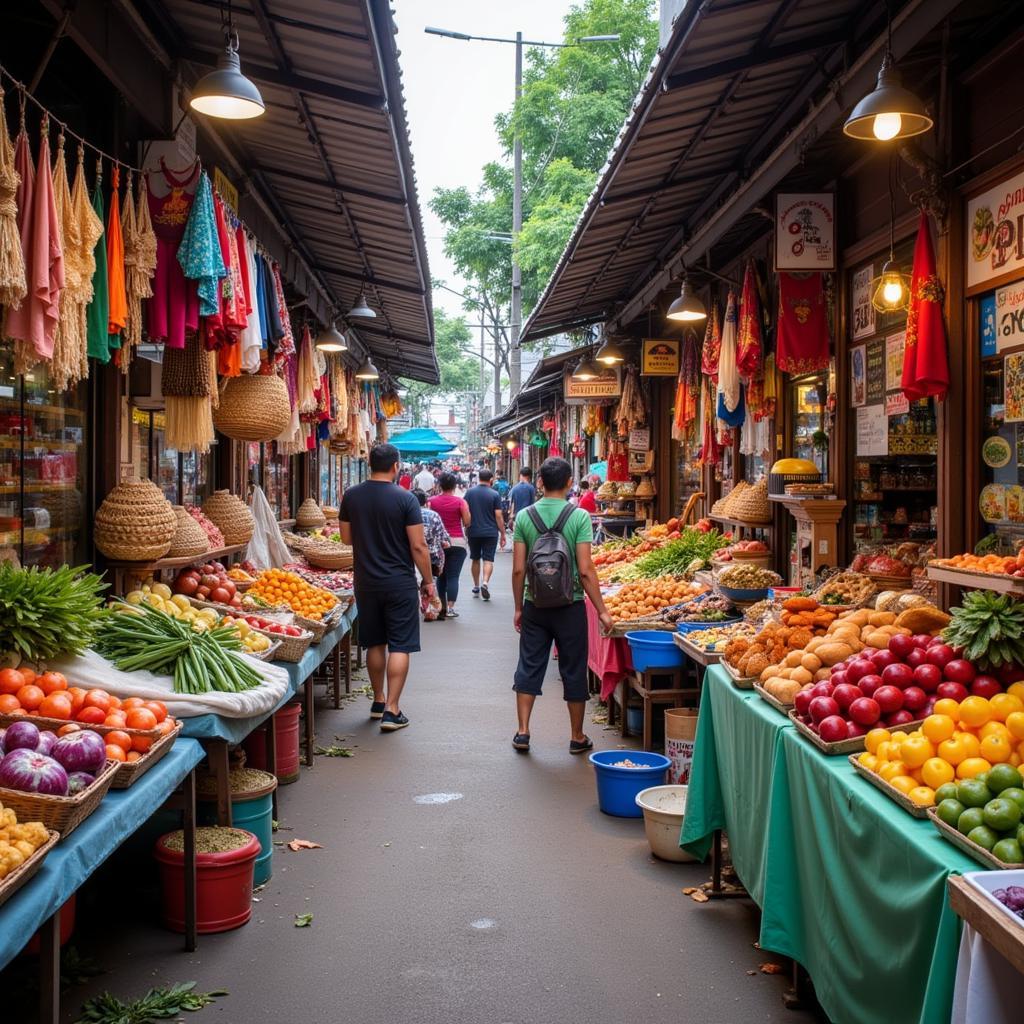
[680,668,978,1024]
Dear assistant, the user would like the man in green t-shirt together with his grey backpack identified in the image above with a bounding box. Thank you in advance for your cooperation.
[512,459,613,754]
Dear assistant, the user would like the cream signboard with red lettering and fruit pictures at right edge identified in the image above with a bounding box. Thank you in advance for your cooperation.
[967,171,1024,290]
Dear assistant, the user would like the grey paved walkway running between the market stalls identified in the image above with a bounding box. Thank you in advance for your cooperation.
[58,554,812,1024]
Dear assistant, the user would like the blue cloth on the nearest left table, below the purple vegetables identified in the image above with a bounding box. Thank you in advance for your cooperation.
[0,736,205,970]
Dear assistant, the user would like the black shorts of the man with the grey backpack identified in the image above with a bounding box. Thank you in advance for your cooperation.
[512,601,590,700]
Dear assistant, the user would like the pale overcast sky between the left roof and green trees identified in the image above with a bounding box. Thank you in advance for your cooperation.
[394,0,571,313]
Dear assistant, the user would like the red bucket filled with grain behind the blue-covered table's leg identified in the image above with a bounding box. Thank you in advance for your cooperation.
[154,828,260,935]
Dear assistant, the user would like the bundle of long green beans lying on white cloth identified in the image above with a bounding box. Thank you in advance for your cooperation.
[94,604,263,693]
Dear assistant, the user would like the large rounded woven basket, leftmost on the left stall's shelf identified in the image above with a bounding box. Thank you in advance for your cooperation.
[94,480,178,562]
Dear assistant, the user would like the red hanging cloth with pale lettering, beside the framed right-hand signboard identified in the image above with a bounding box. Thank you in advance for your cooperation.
[902,210,949,401]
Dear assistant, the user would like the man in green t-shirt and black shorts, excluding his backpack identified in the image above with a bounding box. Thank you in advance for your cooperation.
[512,459,612,754]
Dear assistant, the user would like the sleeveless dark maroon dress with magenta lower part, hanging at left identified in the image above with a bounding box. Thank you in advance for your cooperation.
[146,160,200,348]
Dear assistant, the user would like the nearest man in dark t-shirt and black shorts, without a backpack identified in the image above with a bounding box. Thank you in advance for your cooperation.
[338,444,434,732]
